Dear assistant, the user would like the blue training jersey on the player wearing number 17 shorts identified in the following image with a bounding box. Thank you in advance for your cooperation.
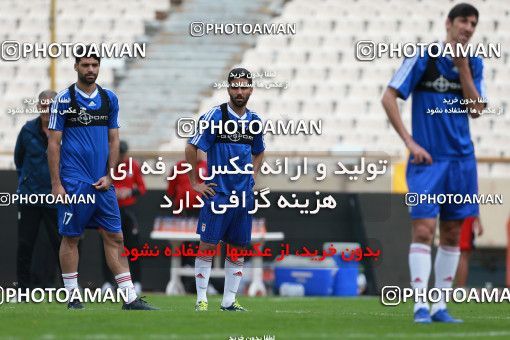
[49,85,119,184]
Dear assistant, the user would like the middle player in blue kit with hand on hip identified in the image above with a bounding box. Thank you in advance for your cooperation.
[185,68,265,311]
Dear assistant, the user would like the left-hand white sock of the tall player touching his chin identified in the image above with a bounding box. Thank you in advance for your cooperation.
[409,243,432,312]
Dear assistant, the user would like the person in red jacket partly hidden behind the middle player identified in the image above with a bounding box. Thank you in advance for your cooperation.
[166,153,207,216]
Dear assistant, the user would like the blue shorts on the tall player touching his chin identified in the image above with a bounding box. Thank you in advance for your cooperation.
[406,157,479,221]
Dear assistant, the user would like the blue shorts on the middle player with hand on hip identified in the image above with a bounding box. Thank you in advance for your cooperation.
[197,192,255,247]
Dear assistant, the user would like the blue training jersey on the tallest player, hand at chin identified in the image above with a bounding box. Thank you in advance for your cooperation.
[388,42,486,160]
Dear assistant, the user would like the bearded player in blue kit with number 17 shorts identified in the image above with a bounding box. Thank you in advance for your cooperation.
[48,47,154,310]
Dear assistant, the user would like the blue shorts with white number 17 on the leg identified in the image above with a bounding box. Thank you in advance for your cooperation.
[58,179,122,236]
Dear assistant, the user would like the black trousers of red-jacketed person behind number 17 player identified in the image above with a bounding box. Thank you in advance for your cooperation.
[103,207,142,284]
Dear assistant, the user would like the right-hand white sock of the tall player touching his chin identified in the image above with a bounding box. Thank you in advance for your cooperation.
[431,246,460,314]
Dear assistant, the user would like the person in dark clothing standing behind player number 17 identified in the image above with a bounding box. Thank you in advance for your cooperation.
[14,90,60,288]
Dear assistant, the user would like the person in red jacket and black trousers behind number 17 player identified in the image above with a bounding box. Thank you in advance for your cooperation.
[103,141,147,294]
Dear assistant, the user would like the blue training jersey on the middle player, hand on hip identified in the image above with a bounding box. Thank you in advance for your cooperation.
[188,105,265,195]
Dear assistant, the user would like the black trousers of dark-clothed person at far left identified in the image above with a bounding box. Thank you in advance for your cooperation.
[17,205,61,288]
